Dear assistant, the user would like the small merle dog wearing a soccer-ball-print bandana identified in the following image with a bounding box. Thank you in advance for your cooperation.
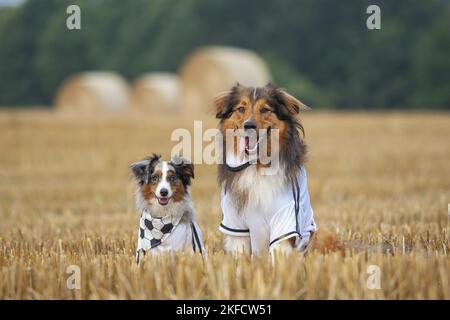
[131,154,204,263]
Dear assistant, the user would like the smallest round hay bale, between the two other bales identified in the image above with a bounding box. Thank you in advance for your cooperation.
[131,73,180,112]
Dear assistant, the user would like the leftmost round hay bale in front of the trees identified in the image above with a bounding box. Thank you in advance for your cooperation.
[56,72,129,113]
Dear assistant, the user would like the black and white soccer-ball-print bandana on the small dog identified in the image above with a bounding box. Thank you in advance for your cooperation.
[137,209,181,251]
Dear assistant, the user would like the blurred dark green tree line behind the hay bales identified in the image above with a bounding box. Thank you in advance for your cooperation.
[0,0,450,109]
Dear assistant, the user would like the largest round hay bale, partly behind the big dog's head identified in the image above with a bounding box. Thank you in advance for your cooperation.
[180,47,270,112]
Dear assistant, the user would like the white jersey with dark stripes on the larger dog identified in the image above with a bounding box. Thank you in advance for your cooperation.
[219,166,316,254]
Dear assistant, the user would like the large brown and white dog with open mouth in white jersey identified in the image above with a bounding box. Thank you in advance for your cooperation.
[214,84,340,254]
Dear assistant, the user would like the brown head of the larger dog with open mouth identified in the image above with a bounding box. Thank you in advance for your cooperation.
[214,84,308,159]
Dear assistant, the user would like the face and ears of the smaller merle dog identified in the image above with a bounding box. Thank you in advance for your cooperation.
[131,155,194,206]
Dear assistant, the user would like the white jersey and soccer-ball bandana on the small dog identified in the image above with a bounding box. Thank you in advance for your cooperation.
[136,210,204,263]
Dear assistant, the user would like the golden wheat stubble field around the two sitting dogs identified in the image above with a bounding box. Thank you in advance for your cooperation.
[0,111,450,299]
